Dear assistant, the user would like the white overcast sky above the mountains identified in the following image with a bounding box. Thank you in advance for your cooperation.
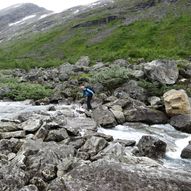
[0,0,97,12]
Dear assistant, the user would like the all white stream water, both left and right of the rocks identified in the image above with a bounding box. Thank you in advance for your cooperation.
[0,101,191,169]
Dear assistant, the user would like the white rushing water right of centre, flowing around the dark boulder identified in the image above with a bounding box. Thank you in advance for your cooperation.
[99,124,191,171]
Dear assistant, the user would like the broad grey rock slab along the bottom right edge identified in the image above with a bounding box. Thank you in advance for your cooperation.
[64,160,191,191]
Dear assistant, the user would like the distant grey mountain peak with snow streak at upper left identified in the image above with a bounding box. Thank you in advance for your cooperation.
[0,3,52,42]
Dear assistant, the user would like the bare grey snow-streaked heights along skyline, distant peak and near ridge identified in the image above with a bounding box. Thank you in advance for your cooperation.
[0,0,112,41]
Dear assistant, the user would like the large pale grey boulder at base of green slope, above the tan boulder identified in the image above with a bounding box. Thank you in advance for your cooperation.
[144,60,179,85]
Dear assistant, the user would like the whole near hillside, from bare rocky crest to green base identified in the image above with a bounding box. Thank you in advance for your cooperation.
[0,0,191,68]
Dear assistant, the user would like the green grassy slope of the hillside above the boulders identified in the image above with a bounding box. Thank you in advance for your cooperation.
[0,0,191,68]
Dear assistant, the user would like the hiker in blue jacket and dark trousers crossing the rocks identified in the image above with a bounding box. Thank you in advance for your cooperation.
[80,85,95,111]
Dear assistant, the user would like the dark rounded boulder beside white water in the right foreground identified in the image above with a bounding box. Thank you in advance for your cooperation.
[137,135,167,159]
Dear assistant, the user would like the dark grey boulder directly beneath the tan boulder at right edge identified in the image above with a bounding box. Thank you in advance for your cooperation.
[170,114,191,133]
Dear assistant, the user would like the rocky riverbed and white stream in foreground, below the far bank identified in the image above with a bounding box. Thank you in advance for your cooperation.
[0,101,191,191]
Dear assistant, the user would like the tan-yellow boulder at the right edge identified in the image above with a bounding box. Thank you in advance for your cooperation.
[163,89,191,116]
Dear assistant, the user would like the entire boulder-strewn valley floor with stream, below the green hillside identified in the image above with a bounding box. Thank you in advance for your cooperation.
[0,57,191,191]
